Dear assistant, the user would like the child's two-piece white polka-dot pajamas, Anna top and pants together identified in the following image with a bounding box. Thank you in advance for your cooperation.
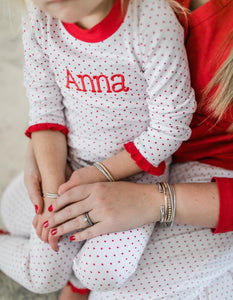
[0,0,198,299]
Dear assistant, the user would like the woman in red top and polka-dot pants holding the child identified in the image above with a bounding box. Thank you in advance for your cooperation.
[1,0,233,299]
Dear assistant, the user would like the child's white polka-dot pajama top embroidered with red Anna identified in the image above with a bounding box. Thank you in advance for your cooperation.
[23,0,195,171]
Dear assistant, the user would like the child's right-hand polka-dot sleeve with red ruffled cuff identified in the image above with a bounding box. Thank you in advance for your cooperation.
[125,1,196,175]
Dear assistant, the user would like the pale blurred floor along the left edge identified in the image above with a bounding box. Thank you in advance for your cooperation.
[0,0,57,300]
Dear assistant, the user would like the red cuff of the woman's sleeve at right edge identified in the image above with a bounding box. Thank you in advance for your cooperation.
[212,177,233,233]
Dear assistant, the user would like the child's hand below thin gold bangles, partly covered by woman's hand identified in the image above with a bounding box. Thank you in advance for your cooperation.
[58,166,108,195]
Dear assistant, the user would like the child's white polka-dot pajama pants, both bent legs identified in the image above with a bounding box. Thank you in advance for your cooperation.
[0,172,168,293]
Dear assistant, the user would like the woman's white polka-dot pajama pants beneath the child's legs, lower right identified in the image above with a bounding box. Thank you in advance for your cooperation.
[89,162,233,300]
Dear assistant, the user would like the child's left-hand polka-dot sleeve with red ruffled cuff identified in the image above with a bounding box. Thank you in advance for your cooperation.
[23,8,68,137]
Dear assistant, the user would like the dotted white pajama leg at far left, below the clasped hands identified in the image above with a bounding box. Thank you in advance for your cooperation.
[0,174,82,294]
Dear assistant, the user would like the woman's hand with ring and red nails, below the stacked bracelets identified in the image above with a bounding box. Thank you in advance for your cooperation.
[47,182,164,241]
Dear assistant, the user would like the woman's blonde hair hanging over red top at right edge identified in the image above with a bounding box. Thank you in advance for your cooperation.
[202,30,233,121]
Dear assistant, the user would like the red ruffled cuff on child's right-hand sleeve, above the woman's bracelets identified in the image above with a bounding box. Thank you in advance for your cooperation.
[124,142,166,176]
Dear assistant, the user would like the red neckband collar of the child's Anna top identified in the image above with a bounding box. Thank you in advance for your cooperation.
[62,0,129,43]
